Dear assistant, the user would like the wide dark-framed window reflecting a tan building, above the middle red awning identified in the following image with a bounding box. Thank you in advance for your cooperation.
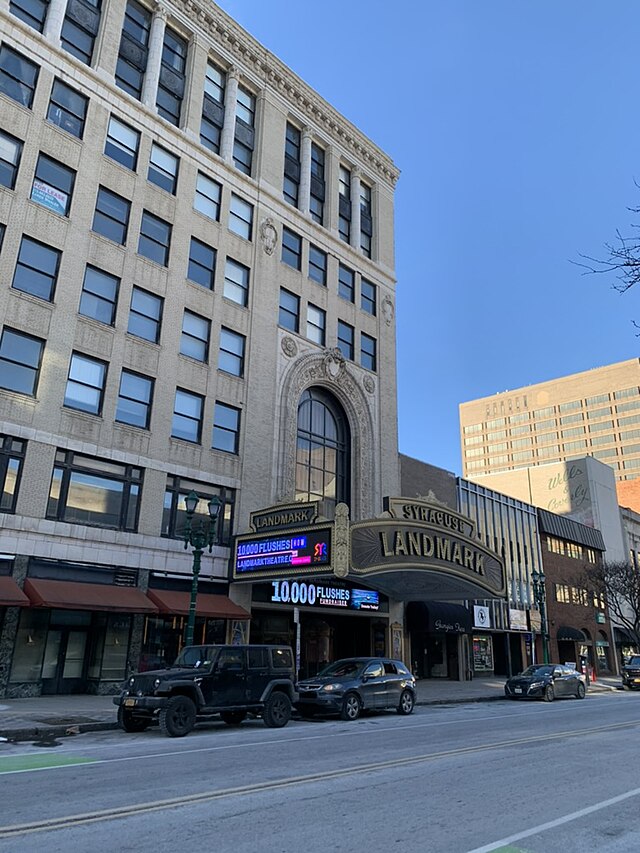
[47,450,142,531]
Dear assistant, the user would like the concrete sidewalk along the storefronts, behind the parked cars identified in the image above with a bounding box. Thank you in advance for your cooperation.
[0,677,620,740]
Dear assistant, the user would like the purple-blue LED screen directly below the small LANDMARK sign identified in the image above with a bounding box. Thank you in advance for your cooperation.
[234,527,331,577]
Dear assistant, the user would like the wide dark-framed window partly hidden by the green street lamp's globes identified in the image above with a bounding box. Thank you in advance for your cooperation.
[162,476,236,545]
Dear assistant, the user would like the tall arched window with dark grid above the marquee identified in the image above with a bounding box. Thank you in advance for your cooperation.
[296,388,351,518]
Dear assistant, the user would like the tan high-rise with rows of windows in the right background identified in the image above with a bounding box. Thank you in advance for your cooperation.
[460,358,640,491]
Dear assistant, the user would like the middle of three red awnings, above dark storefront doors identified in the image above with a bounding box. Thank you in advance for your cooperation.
[24,578,158,613]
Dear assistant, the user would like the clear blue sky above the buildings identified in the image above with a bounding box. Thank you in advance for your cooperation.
[219,0,640,474]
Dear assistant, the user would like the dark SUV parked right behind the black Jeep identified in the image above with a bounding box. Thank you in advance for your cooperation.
[296,658,416,720]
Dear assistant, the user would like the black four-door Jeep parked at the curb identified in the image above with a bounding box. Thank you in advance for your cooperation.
[113,646,297,737]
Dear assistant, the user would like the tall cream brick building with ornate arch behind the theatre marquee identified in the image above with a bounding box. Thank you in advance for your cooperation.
[0,0,399,696]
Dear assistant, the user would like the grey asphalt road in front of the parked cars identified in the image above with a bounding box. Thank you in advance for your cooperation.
[0,693,640,853]
